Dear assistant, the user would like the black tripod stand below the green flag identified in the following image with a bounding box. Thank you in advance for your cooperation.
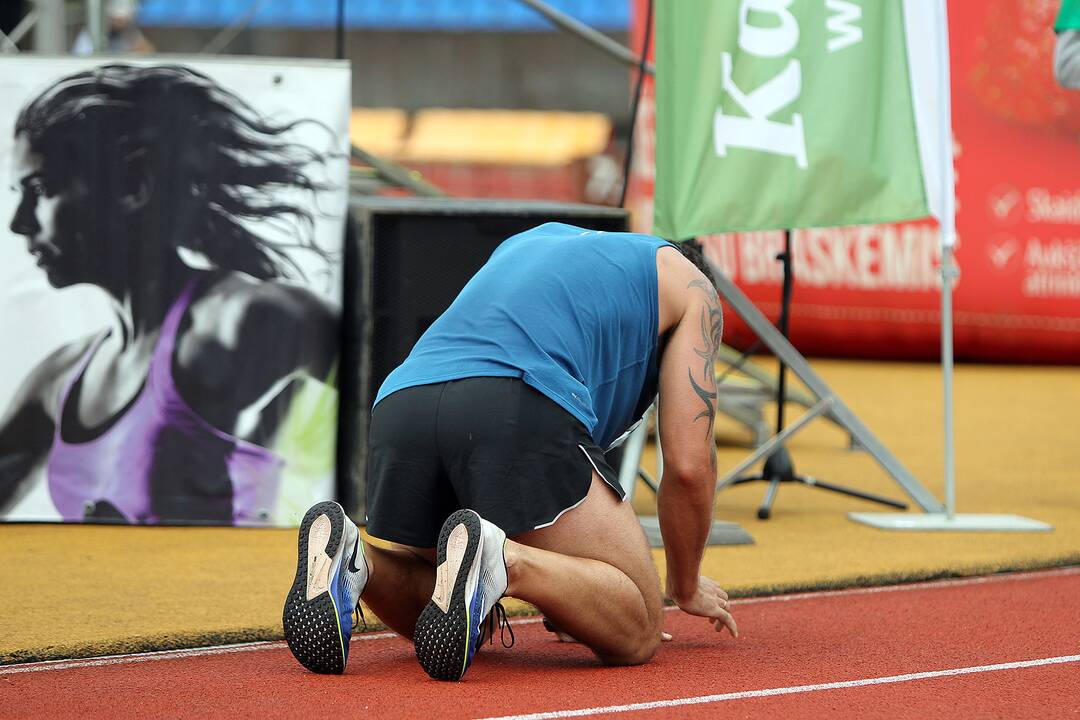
[729,230,907,520]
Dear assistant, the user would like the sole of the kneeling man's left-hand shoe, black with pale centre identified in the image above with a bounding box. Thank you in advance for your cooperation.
[281,502,346,675]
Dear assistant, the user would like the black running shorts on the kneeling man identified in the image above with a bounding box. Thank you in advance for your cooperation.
[367,378,623,547]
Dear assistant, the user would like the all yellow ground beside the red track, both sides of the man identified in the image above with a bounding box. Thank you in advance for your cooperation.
[0,361,1080,663]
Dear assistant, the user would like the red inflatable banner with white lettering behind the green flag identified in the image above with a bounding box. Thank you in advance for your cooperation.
[629,0,1080,363]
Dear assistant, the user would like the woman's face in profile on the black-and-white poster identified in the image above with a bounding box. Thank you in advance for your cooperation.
[10,134,93,287]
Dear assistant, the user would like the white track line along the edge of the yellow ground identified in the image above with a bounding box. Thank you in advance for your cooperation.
[0,567,1080,676]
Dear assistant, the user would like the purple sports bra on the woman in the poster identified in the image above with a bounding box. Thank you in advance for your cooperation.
[46,280,284,525]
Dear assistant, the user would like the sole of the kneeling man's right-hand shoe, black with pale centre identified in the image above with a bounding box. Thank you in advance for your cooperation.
[413,511,481,680]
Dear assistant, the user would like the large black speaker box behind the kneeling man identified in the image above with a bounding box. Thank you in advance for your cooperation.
[337,196,629,520]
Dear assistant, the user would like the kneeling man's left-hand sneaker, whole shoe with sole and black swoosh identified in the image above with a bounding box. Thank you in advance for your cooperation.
[282,502,368,674]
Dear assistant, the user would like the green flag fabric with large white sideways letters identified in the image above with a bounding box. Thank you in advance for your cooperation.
[654,0,934,240]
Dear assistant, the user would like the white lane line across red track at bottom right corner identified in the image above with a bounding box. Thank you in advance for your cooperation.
[484,655,1080,720]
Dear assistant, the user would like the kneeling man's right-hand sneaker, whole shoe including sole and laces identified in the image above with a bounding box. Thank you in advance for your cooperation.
[413,510,507,680]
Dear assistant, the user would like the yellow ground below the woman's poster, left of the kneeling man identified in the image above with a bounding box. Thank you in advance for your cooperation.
[0,525,296,662]
